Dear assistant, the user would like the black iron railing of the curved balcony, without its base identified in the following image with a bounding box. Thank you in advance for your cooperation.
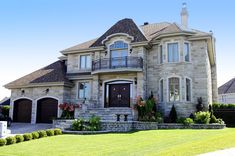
[92,56,143,71]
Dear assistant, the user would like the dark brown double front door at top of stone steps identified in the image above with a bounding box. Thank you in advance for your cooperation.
[109,83,130,107]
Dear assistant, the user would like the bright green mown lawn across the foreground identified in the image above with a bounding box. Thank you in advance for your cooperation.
[0,128,235,156]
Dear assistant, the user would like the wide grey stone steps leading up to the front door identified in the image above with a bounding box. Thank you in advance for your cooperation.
[75,107,134,121]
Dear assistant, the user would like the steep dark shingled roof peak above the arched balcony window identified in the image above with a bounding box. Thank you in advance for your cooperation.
[91,18,147,47]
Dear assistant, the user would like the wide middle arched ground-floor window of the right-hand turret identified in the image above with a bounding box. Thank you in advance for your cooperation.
[168,77,180,102]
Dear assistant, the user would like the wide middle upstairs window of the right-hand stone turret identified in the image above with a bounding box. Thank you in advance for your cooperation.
[167,43,179,62]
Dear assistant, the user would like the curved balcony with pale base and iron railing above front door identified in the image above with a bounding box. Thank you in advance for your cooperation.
[92,56,143,74]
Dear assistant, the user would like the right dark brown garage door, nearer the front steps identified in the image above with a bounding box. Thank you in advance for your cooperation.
[37,98,58,123]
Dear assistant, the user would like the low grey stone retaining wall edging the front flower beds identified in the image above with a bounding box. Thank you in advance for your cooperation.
[53,120,226,134]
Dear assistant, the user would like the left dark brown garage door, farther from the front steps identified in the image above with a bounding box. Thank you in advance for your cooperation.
[13,99,32,123]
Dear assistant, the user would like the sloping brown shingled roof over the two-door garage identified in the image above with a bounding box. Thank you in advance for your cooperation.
[5,61,69,88]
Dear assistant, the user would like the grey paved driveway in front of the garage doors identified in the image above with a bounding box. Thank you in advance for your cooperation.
[8,123,52,134]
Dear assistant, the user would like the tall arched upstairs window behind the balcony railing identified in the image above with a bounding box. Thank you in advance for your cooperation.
[109,41,128,67]
